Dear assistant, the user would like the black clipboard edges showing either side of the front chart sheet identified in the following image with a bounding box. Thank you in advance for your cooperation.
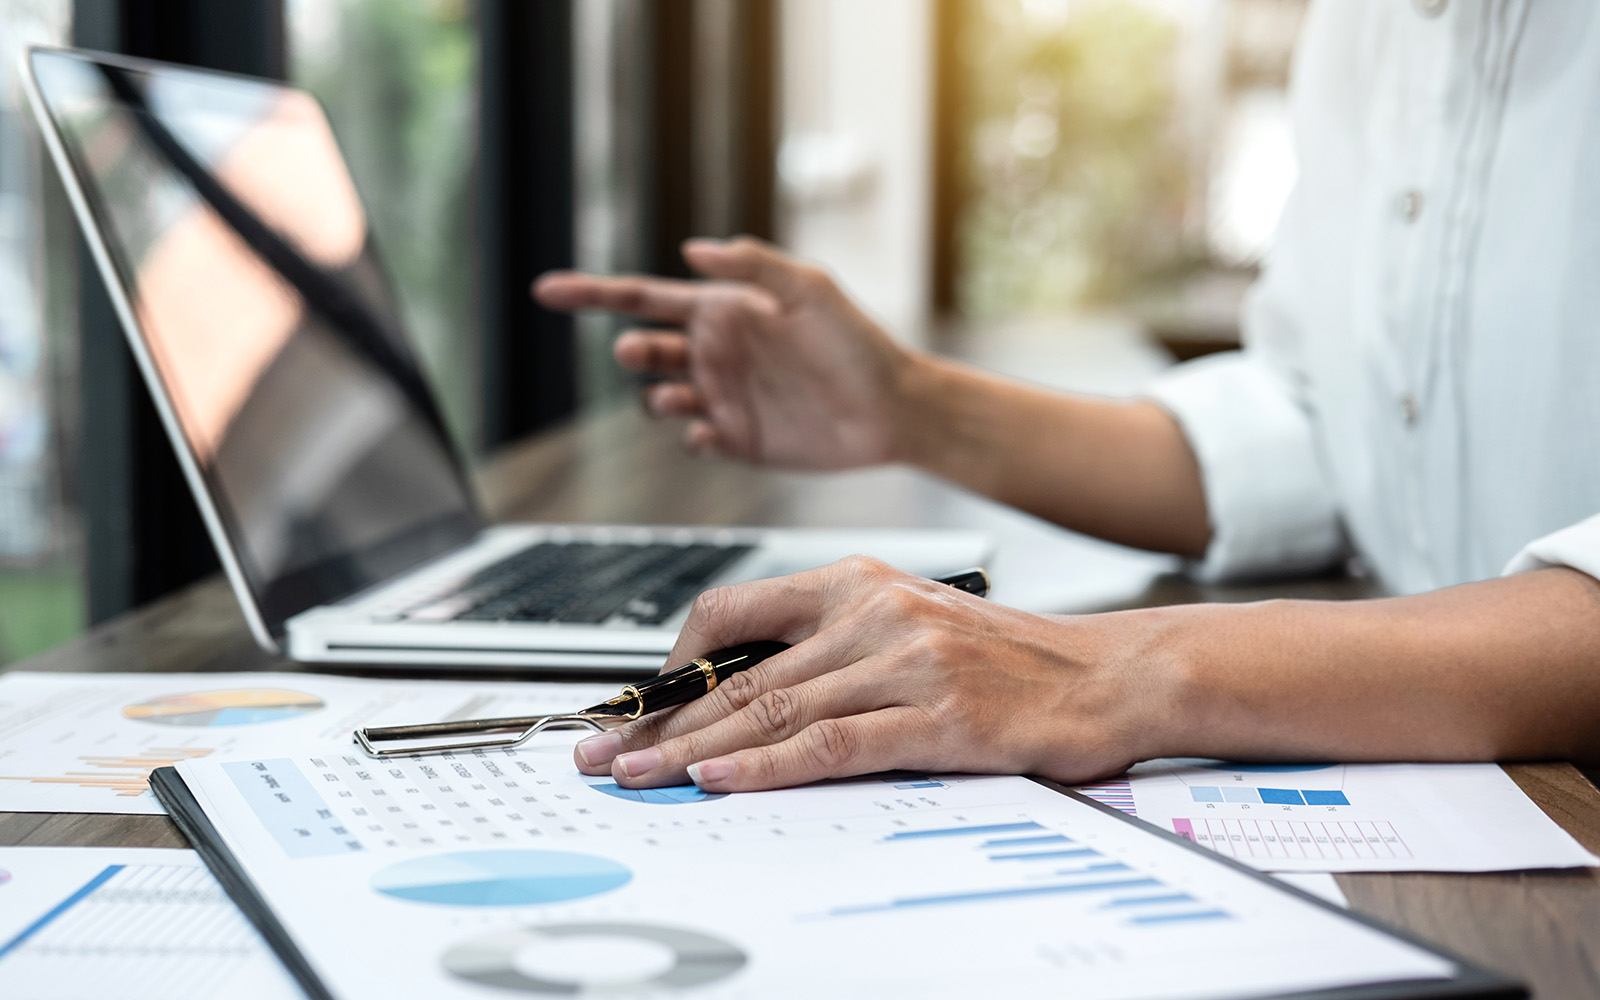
[150,766,1530,1000]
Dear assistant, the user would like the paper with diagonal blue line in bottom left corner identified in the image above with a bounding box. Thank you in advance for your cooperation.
[0,848,304,1000]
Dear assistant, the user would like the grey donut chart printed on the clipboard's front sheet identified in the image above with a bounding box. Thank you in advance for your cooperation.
[443,922,749,997]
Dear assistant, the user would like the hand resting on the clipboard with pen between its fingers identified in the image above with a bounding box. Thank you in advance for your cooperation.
[574,557,1179,792]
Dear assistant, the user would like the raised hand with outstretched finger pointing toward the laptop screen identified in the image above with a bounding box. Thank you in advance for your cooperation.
[534,238,914,469]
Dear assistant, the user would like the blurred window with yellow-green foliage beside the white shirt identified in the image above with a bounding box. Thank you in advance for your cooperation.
[941,0,1306,336]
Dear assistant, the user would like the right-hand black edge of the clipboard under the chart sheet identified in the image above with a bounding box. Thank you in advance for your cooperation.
[1027,774,1531,1000]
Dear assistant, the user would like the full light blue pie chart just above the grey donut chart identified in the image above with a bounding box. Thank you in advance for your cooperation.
[373,851,634,906]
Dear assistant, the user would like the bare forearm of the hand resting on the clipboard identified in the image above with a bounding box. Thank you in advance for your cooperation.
[1141,570,1600,760]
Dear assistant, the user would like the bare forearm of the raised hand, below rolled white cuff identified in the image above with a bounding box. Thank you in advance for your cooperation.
[894,350,1211,557]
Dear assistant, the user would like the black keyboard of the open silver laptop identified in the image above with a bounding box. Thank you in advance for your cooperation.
[396,542,752,626]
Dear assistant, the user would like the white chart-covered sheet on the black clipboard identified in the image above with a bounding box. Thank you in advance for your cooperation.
[168,733,1453,1000]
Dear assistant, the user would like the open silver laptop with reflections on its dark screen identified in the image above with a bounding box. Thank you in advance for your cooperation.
[24,48,989,670]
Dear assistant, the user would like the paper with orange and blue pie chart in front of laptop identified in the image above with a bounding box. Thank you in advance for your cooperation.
[0,670,616,813]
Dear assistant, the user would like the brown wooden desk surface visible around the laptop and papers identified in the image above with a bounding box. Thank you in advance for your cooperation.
[0,411,1600,998]
